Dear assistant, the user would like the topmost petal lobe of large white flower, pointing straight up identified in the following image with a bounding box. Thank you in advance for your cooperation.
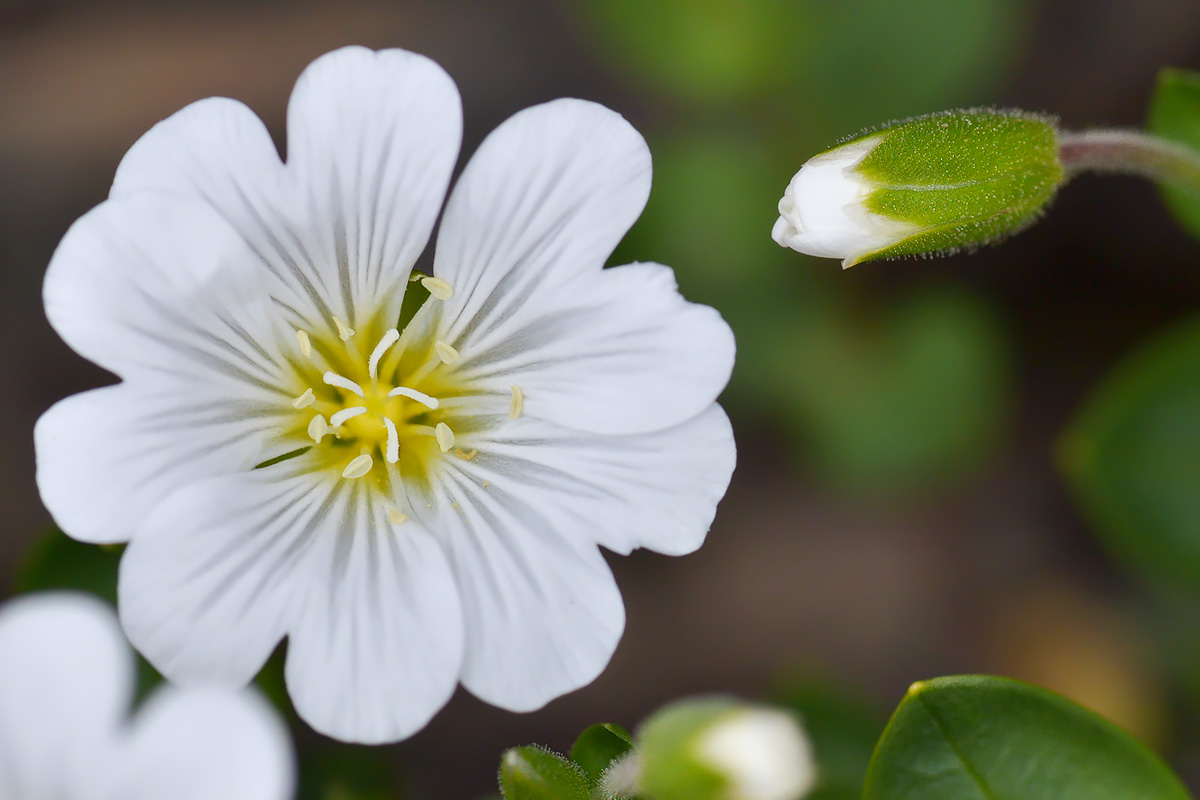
[288,47,462,327]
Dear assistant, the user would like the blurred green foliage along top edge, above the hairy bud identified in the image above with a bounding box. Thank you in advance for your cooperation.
[577,0,1025,125]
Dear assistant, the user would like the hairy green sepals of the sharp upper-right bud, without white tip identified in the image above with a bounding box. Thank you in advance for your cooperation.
[847,109,1064,266]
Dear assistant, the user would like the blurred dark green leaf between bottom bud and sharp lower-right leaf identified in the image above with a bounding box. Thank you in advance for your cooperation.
[780,682,884,800]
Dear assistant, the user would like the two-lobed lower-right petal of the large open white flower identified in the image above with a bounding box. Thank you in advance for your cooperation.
[413,405,734,710]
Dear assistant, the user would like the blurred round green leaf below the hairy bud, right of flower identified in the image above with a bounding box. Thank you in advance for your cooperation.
[777,289,1012,495]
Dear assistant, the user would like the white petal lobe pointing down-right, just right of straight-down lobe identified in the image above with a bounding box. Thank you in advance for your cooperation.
[412,462,625,711]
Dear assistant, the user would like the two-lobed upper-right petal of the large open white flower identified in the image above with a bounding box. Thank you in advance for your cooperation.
[433,100,734,433]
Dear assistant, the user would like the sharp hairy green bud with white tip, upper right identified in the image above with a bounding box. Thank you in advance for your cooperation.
[772,108,1066,267]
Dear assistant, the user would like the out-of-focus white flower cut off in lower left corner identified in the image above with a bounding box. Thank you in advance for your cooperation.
[0,593,294,800]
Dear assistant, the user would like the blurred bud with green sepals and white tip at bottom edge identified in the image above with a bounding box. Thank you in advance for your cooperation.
[634,697,816,800]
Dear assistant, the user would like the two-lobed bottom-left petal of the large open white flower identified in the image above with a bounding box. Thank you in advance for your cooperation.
[120,470,463,744]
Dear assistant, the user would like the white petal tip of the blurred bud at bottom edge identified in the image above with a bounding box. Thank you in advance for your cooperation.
[696,708,817,800]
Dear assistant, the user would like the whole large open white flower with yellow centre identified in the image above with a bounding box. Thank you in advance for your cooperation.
[36,48,734,742]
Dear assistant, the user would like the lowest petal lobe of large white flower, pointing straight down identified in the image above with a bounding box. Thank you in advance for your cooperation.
[286,489,463,744]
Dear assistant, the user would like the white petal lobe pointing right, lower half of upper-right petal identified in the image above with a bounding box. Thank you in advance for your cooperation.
[451,264,734,434]
